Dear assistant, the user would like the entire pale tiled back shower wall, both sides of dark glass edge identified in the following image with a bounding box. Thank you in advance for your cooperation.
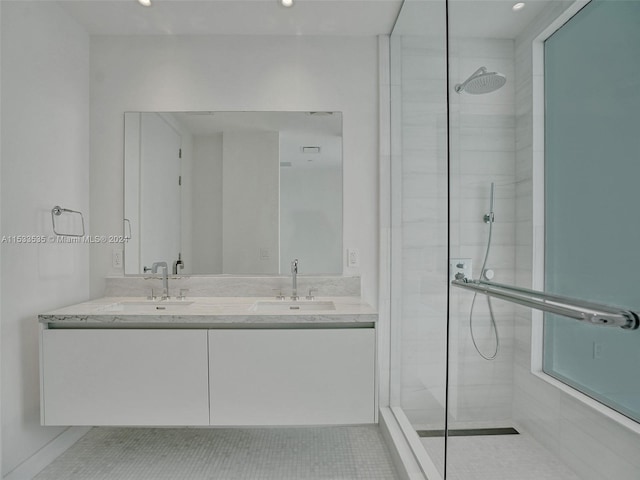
[394,36,515,428]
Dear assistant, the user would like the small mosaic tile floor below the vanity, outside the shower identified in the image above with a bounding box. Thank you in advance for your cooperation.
[34,425,399,480]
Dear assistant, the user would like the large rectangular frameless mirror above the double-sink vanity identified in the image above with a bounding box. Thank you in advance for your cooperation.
[124,112,342,275]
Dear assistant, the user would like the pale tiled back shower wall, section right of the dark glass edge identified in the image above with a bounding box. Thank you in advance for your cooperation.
[449,37,516,428]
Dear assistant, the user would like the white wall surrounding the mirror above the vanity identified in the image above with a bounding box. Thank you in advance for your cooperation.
[91,36,378,305]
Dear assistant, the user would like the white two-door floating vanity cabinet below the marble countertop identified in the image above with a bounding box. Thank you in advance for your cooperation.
[40,319,375,426]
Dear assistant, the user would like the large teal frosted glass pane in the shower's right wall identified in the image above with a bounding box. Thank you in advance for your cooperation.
[544,0,640,422]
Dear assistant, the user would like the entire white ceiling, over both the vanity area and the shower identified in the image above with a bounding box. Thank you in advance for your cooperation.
[58,0,552,38]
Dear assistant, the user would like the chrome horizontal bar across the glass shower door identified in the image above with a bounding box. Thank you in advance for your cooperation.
[451,278,640,330]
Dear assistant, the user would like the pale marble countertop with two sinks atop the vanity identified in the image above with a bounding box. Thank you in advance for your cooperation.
[38,297,378,328]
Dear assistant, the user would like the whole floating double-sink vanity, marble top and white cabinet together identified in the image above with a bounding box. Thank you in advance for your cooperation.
[39,297,377,426]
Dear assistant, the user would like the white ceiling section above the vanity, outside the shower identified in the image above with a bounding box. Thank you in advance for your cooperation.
[58,0,402,36]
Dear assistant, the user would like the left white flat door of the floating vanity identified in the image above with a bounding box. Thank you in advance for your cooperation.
[41,329,209,425]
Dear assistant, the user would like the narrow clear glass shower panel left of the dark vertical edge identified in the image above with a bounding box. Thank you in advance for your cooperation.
[390,0,448,475]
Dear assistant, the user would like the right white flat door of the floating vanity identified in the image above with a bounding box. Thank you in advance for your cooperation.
[209,328,375,425]
